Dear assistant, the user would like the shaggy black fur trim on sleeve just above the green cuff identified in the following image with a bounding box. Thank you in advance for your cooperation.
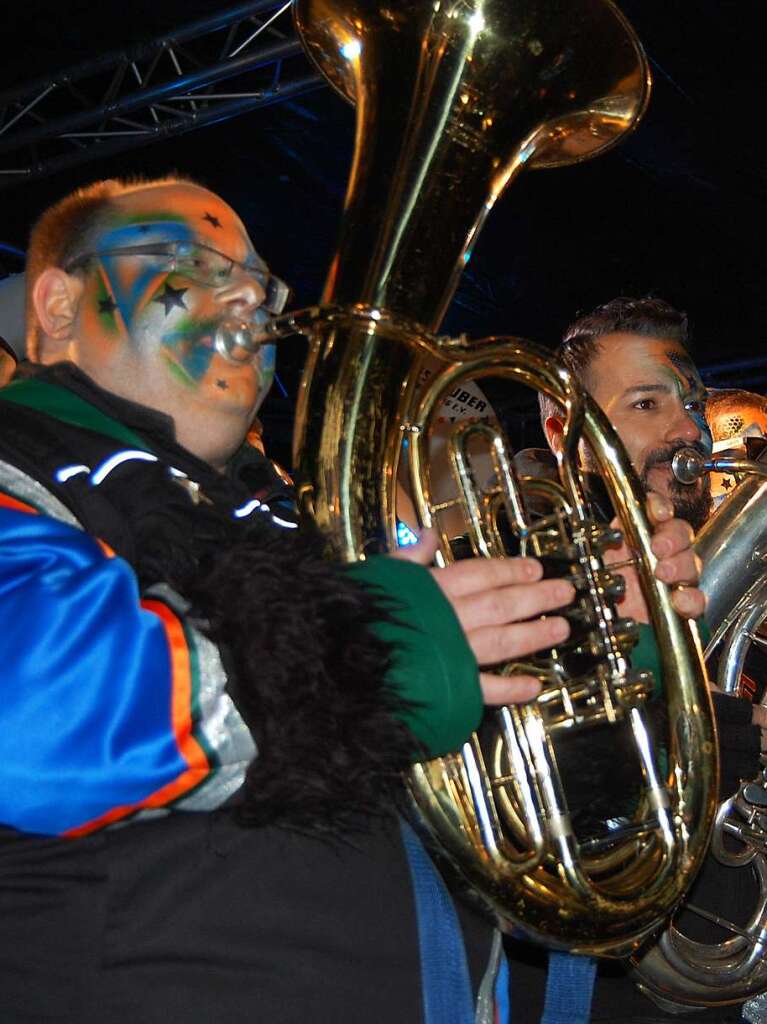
[186,530,415,833]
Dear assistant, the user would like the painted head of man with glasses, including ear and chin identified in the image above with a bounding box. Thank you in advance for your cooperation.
[28,175,287,469]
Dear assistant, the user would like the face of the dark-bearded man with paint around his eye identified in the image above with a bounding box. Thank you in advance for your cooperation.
[585,333,711,528]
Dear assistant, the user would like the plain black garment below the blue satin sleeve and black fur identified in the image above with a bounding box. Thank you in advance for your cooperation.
[0,810,492,1024]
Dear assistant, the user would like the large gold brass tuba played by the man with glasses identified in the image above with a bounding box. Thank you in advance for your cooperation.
[257,0,716,951]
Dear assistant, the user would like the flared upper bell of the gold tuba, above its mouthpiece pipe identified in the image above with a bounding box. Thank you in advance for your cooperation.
[296,0,649,330]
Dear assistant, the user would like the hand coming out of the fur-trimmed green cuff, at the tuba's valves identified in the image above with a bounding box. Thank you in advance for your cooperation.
[394,531,576,705]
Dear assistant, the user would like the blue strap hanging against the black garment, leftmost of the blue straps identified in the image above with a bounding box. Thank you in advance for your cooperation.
[399,819,475,1024]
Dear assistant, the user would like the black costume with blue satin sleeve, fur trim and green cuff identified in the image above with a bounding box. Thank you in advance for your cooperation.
[0,366,493,1024]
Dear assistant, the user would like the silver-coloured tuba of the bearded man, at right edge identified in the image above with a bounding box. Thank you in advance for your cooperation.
[634,450,767,1007]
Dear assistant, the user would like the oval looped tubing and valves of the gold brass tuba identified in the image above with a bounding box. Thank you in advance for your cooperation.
[410,346,716,954]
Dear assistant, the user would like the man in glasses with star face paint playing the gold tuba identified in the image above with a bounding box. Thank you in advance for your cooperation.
[0,179,702,1024]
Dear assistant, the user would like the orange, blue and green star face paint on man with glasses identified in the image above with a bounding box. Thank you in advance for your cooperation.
[68,185,274,423]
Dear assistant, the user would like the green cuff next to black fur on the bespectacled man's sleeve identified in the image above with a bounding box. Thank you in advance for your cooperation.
[348,556,482,757]
